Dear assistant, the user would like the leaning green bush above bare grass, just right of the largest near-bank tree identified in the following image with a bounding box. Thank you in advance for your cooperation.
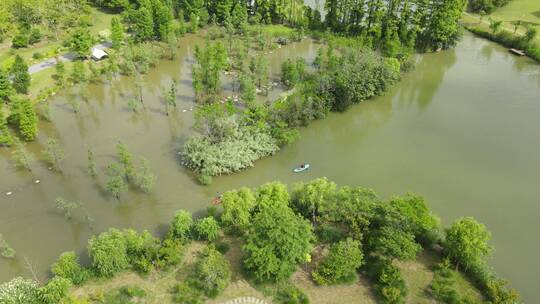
[311,238,364,285]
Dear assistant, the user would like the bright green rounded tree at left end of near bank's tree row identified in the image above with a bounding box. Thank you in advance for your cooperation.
[88,228,129,278]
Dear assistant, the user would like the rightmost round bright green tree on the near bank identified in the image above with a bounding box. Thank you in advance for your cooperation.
[445,217,492,269]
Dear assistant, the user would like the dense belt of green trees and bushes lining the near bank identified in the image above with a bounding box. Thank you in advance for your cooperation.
[0,178,519,304]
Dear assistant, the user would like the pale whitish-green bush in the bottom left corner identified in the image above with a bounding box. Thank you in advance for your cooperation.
[0,277,42,304]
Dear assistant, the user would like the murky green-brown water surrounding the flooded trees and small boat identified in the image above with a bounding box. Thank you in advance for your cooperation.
[0,35,540,302]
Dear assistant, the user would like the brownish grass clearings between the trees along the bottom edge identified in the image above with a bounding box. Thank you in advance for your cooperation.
[71,239,482,304]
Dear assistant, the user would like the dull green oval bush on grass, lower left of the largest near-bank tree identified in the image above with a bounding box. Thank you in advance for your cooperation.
[194,246,231,298]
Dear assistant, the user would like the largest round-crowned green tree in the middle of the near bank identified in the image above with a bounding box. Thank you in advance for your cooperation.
[242,204,313,281]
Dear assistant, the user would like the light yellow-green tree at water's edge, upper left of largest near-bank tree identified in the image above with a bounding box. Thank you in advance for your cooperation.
[221,187,255,232]
